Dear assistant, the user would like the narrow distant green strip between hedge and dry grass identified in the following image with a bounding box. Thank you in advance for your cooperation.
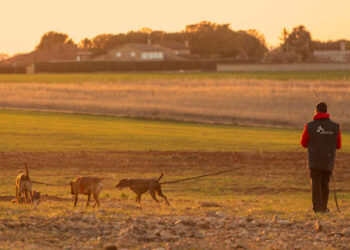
[0,71,350,83]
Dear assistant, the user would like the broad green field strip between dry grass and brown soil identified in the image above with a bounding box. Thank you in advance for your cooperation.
[0,110,350,152]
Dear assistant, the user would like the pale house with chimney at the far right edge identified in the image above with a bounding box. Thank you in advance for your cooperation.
[313,43,350,63]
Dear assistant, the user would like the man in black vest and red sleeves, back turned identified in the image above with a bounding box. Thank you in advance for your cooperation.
[301,102,341,213]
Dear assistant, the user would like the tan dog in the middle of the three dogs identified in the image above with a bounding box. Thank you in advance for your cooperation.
[70,177,103,207]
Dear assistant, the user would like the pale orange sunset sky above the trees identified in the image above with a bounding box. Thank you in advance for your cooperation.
[0,0,350,55]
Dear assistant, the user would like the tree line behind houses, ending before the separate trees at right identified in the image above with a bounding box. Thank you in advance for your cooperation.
[36,21,267,60]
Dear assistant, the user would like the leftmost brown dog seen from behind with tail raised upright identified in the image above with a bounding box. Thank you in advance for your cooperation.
[16,163,33,204]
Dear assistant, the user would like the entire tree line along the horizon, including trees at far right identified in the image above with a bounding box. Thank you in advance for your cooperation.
[6,21,350,62]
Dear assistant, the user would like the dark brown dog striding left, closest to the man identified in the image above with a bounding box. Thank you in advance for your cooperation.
[115,173,170,205]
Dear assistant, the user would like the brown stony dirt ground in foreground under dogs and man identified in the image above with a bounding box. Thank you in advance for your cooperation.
[0,151,350,249]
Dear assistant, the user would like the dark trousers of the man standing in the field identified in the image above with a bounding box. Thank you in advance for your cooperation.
[310,169,332,212]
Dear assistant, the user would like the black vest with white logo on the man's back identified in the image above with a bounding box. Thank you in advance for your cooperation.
[307,119,339,172]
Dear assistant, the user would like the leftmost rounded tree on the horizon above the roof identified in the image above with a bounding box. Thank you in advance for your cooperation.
[36,31,75,51]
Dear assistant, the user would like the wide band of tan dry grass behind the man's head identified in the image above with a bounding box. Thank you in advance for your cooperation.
[0,79,350,129]
